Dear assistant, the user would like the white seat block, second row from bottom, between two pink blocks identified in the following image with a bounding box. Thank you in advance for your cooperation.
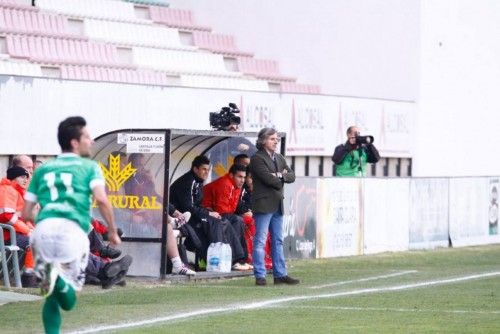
[132,47,236,76]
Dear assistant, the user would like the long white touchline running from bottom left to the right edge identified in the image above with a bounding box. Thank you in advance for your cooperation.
[72,271,500,334]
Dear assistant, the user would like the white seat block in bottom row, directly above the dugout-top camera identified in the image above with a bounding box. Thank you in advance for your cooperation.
[180,74,269,92]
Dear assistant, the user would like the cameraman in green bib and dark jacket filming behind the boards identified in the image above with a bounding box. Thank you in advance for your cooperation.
[332,126,380,176]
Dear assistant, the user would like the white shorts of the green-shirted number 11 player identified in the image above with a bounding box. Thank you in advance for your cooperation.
[30,218,89,291]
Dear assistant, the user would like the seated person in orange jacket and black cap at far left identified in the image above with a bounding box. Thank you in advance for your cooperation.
[0,166,38,287]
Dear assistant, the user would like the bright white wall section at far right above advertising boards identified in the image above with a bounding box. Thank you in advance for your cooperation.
[413,0,500,176]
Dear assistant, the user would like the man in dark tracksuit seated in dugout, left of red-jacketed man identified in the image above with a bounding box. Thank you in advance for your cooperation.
[170,156,245,268]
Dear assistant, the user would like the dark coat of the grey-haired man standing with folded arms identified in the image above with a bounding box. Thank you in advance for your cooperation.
[250,150,295,214]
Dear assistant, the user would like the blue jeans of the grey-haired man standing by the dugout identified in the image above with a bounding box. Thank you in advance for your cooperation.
[253,211,287,278]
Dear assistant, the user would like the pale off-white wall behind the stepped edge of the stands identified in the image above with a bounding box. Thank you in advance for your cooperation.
[169,0,419,101]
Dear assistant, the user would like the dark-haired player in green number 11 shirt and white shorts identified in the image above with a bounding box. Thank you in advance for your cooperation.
[23,117,121,333]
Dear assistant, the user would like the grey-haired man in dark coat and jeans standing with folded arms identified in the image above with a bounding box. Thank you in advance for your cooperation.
[250,128,300,286]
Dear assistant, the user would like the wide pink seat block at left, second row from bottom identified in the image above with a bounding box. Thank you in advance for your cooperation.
[6,35,132,67]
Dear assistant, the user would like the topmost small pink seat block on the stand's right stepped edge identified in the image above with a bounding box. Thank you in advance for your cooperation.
[149,6,210,31]
